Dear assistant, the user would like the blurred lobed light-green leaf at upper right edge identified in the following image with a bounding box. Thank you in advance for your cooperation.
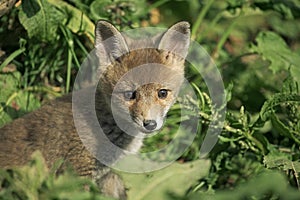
[250,31,300,82]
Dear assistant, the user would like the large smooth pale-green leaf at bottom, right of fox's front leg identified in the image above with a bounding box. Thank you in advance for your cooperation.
[121,160,210,200]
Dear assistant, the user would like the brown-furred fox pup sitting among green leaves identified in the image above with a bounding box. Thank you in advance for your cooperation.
[0,20,190,199]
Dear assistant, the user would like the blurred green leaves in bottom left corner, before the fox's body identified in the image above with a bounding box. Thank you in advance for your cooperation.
[0,151,111,200]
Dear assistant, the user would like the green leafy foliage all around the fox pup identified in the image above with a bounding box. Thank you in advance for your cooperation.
[0,0,300,199]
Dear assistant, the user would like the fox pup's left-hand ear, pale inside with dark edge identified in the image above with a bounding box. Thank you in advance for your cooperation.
[95,20,129,64]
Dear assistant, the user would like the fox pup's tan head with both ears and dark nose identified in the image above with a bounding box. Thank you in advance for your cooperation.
[95,21,190,133]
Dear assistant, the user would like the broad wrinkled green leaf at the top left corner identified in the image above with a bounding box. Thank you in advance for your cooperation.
[19,0,66,41]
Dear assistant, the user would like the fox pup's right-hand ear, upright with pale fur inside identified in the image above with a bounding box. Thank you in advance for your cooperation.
[158,22,190,59]
